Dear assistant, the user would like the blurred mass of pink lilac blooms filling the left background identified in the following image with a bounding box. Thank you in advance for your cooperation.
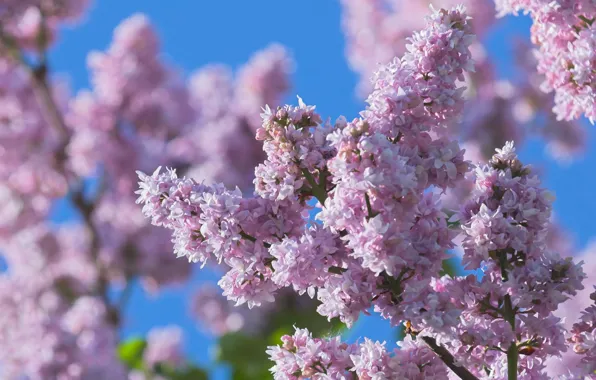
[0,0,292,379]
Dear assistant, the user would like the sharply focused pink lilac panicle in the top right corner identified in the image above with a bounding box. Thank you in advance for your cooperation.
[496,0,596,123]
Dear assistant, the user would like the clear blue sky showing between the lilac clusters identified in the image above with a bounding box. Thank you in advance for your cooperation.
[51,0,596,378]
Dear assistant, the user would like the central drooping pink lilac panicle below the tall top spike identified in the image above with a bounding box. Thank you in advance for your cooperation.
[317,119,468,325]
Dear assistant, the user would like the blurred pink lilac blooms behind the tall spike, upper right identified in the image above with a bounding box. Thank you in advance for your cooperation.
[342,0,594,160]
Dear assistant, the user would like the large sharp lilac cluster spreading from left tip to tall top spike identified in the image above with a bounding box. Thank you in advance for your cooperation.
[137,8,472,324]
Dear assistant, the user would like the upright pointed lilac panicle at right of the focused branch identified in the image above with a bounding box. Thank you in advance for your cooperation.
[463,143,552,267]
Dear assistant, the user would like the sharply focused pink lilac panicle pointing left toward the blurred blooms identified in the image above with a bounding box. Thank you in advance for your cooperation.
[138,169,304,307]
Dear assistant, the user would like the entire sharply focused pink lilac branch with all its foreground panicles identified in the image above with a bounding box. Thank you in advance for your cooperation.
[137,7,585,379]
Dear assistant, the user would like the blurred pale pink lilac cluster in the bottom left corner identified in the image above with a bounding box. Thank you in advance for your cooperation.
[0,226,126,379]
